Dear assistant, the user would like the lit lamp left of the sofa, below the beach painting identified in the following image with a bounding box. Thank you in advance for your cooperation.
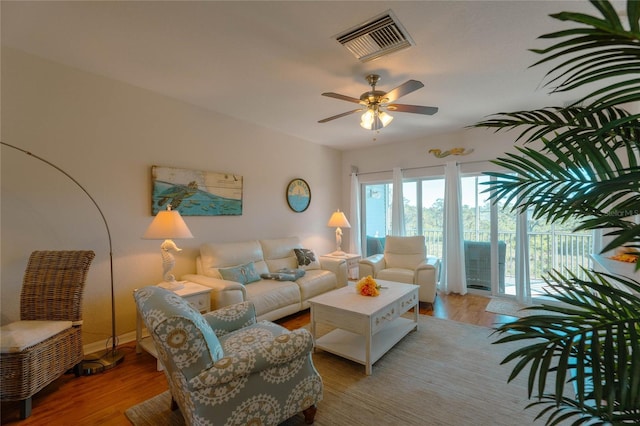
[142,204,193,290]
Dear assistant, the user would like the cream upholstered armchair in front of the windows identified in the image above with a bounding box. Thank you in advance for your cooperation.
[360,236,440,303]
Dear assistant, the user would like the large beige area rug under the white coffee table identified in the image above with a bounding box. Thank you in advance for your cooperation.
[125,315,564,426]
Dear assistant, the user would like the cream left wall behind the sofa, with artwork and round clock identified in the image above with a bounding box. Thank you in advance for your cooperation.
[0,47,342,344]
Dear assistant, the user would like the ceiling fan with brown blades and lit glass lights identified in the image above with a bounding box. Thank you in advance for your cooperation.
[318,74,438,130]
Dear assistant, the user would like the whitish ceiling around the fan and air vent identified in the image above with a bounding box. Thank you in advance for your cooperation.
[1,0,612,149]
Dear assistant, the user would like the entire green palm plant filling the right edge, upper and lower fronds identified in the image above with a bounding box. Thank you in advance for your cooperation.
[475,0,640,424]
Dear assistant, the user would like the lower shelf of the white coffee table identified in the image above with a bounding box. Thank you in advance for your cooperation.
[316,317,418,374]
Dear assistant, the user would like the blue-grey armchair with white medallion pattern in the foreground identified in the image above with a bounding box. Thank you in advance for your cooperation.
[134,286,322,425]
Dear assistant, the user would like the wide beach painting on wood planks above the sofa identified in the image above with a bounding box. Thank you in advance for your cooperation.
[151,166,242,216]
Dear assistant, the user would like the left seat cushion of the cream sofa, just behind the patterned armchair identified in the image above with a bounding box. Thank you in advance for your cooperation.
[246,280,301,317]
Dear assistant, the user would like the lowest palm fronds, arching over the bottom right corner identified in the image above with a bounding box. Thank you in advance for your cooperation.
[495,270,640,423]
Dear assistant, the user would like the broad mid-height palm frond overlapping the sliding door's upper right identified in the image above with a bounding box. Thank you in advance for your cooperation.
[484,146,640,229]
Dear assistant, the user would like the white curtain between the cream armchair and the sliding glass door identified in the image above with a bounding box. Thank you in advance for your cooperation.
[440,162,467,294]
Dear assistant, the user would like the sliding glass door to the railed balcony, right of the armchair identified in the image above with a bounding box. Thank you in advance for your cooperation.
[461,171,593,297]
